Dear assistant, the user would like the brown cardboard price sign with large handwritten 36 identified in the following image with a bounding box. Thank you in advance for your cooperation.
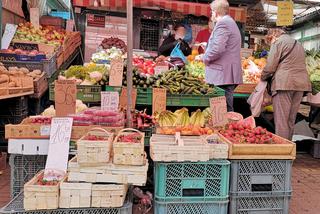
[54,80,77,117]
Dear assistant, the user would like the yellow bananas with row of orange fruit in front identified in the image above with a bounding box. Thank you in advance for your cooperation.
[155,108,213,135]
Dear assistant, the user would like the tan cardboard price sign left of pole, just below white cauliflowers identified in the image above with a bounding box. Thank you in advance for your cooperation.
[109,58,123,86]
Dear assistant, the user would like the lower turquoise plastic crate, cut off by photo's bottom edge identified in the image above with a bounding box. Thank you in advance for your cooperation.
[154,201,228,214]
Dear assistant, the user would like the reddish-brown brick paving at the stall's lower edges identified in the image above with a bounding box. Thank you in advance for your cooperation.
[0,154,320,214]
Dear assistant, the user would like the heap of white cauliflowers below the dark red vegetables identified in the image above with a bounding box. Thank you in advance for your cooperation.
[91,47,123,64]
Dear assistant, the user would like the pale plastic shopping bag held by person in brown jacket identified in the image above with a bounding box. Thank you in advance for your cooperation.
[248,81,272,117]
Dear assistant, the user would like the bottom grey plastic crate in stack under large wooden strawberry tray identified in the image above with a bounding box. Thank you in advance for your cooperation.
[229,193,291,214]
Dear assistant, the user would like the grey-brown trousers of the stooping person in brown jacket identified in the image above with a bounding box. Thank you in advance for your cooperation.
[272,91,303,140]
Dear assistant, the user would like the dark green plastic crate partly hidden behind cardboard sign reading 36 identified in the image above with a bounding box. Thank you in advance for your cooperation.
[49,83,101,103]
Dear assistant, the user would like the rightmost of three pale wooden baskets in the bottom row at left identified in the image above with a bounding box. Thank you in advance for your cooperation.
[91,184,128,207]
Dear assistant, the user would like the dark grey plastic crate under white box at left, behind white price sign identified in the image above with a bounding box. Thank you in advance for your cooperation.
[9,154,47,198]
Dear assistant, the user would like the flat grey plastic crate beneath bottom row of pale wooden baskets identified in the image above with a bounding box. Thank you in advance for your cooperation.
[0,192,132,214]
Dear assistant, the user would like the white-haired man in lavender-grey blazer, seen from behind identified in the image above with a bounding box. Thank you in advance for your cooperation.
[203,0,242,111]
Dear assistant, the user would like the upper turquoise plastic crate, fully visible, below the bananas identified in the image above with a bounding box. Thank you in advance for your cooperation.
[154,160,230,202]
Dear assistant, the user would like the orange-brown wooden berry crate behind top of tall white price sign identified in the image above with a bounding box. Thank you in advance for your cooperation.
[5,118,123,140]
